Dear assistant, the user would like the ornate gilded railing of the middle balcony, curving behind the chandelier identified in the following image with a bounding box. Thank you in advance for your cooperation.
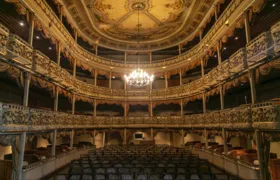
[0,22,280,101]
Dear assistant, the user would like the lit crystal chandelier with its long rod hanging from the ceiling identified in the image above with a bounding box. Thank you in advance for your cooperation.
[124,5,154,87]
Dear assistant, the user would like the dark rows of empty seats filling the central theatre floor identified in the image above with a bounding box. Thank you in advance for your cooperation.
[54,145,238,180]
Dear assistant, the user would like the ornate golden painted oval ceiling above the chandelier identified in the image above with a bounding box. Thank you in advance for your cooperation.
[58,0,214,51]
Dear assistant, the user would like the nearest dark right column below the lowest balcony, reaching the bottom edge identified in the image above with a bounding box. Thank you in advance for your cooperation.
[255,129,266,180]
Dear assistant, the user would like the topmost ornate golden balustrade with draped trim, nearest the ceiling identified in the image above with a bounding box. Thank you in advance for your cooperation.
[14,0,259,68]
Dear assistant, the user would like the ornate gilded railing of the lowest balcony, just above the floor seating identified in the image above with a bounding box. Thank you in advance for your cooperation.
[0,101,280,131]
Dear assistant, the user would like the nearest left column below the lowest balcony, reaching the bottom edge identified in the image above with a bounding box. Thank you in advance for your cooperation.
[15,132,26,180]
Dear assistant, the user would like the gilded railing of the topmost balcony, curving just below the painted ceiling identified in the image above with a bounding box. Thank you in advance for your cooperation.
[16,0,253,68]
